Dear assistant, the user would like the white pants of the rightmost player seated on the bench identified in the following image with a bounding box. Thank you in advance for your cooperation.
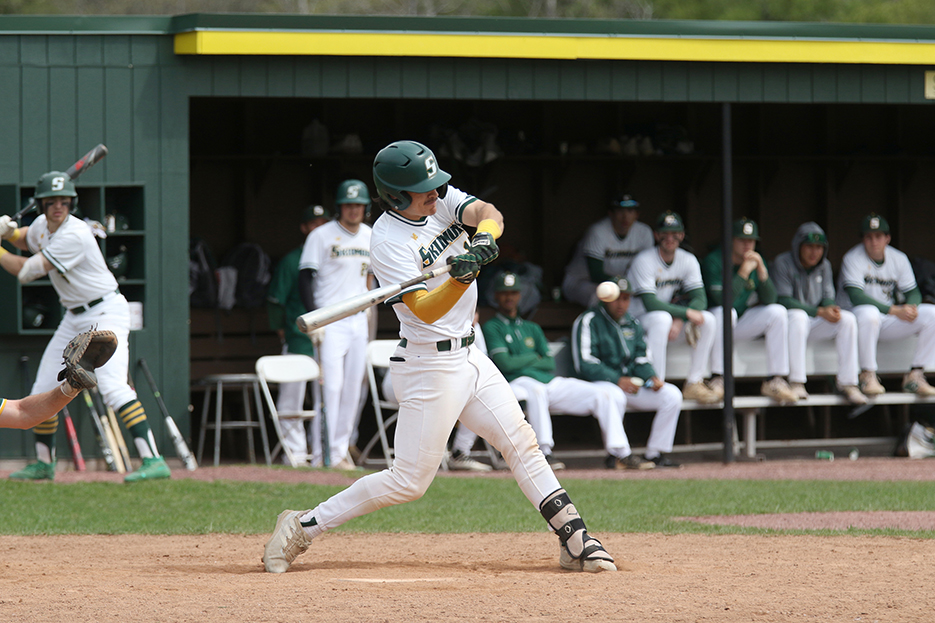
[853,303,935,372]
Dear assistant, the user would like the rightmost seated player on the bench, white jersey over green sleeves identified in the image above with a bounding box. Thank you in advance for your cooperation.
[838,214,935,396]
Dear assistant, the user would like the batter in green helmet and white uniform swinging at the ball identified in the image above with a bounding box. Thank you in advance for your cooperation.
[263,141,617,573]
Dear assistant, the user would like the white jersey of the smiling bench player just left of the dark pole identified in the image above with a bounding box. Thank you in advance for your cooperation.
[627,247,704,317]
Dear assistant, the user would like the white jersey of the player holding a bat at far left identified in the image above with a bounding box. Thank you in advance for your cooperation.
[26,214,117,308]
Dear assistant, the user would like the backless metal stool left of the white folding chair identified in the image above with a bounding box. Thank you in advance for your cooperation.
[198,374,272,467]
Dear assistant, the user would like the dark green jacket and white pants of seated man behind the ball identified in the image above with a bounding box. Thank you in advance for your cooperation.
[571,304,682,458]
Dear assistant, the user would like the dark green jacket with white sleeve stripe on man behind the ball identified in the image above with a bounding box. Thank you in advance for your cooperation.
[568,303,656,385]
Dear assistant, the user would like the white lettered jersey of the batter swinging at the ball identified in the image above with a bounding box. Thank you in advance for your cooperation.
[370,186,477,344]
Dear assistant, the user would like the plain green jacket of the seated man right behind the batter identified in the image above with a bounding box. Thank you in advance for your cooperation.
[482,314,555,383]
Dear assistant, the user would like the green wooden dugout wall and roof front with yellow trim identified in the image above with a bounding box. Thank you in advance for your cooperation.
[0,15,935,458]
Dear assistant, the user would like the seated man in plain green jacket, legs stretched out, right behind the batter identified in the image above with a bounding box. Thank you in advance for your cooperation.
[484,272,651,469]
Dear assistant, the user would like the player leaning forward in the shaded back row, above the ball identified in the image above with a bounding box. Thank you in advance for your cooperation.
[562,195,653,307]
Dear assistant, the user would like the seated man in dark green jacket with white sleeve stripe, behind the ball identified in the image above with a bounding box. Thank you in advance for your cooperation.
[571,278,682,469]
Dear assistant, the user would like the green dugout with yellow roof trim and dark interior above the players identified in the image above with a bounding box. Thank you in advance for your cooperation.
[0,15,935,466]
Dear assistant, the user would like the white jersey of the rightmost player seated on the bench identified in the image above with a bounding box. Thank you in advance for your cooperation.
[837,243,916,309]
